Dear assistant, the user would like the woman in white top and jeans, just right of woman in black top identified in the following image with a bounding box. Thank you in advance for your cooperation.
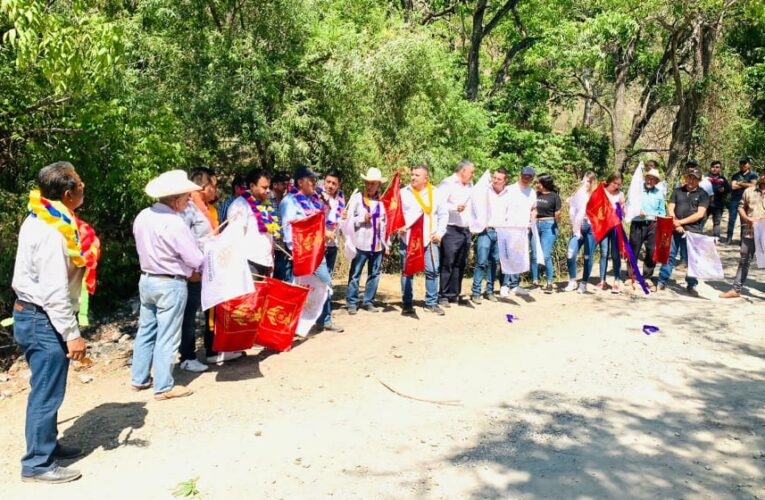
[565,172,598,293]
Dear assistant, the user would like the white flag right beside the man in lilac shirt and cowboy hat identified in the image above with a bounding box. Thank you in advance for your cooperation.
[202,231,255,311]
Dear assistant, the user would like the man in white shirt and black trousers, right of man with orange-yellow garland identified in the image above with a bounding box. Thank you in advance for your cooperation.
[438,160,475,307]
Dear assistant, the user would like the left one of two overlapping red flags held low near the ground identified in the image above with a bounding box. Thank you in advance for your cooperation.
[213,281,269,352]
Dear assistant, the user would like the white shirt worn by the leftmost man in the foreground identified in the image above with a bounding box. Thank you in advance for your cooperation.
[11,217,85,342]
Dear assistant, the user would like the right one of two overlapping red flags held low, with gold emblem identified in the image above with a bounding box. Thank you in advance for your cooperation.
[255,278,310,352]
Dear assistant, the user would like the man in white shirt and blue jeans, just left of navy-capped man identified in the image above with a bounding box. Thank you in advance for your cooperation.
[471,168,510,304]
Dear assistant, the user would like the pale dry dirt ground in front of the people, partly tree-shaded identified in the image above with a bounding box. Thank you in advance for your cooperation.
[0,243,765,499]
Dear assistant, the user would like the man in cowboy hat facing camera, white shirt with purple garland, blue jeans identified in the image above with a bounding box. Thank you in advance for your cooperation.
[345,167,389,314]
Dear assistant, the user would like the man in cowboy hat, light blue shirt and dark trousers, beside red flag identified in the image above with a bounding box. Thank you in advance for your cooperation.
[630,160,667,286]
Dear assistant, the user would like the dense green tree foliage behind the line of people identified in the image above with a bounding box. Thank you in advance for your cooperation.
[0,0,765,311]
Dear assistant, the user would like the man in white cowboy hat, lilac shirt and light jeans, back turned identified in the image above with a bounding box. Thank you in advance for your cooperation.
[131,170,203,400]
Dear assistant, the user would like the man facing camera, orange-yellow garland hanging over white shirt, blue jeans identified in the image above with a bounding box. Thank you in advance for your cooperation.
[399,165,449,316]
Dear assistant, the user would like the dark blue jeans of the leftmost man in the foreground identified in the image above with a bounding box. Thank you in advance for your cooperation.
[13,306,69,476]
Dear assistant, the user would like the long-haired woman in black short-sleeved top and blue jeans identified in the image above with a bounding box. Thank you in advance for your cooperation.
[531,174,561,293]
